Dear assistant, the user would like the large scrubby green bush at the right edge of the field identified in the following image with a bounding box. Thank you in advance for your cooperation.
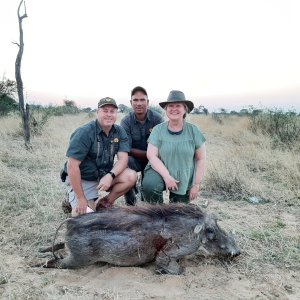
[250,109,300,146]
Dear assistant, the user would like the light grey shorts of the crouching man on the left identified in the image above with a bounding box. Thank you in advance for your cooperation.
[66,176,99,208]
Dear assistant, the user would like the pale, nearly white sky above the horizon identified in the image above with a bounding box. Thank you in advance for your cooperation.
[0,0,300,112]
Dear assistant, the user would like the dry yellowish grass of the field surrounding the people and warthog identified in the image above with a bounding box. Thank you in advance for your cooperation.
[0,114,300,299]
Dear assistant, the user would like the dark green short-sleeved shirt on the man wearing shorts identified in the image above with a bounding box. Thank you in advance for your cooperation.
[65,120,130,181]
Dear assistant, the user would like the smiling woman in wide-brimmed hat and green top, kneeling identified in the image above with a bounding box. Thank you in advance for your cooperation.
[142,91,206,204]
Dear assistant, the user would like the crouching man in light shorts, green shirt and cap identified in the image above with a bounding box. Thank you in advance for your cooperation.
[64,97,137,216]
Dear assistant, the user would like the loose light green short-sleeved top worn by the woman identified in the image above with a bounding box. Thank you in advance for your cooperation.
[148,122,205,195]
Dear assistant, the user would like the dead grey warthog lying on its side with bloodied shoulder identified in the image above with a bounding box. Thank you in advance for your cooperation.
[43,204,240,274]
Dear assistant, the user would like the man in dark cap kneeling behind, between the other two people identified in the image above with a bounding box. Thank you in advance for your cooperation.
[120,86,164,205]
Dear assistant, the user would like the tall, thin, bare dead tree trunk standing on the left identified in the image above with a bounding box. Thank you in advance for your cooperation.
[13,0,31,149]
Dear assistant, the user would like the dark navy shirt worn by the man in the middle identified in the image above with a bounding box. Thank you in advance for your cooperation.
[120,109,164,151]
